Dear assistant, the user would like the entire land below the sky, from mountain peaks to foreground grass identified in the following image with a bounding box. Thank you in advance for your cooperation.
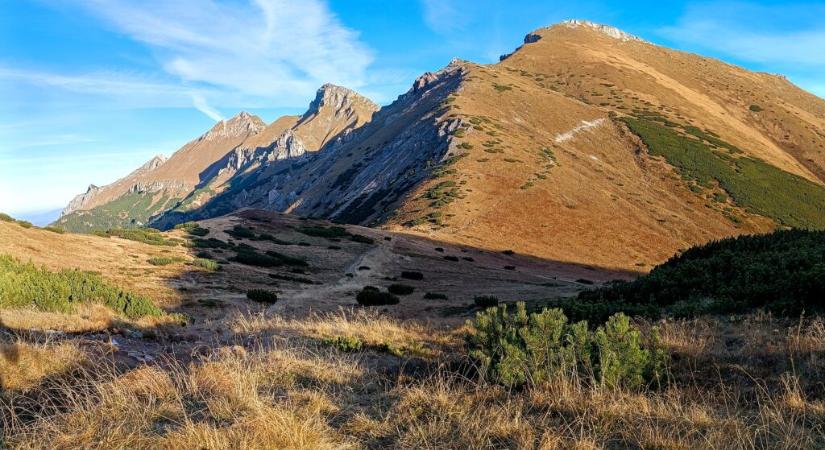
[0,20,825,449]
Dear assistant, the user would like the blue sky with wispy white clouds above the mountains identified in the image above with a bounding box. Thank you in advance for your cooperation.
[0,0,825,222]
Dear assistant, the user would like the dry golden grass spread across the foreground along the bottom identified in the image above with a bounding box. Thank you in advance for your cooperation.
[0,312,825,449]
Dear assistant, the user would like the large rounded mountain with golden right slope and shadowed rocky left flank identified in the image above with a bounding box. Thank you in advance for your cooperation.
[56,21,825,271]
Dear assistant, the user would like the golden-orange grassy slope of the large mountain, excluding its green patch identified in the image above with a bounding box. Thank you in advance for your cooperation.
[389,24,825,271]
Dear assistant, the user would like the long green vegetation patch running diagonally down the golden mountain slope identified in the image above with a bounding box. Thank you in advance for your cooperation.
[623,118,825,229]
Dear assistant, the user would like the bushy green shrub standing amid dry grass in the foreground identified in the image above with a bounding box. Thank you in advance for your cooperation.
[467,302,665,389]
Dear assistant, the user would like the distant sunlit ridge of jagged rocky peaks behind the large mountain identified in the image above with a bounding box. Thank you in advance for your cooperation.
[55,84,378,232]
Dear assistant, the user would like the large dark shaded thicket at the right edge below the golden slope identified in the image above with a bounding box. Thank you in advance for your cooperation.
[557,230,825,319]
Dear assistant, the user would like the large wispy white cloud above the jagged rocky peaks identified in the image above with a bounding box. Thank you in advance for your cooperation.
[71,0,372,109]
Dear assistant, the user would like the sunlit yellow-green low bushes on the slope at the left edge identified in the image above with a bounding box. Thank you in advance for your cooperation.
[0,255,163,319]
